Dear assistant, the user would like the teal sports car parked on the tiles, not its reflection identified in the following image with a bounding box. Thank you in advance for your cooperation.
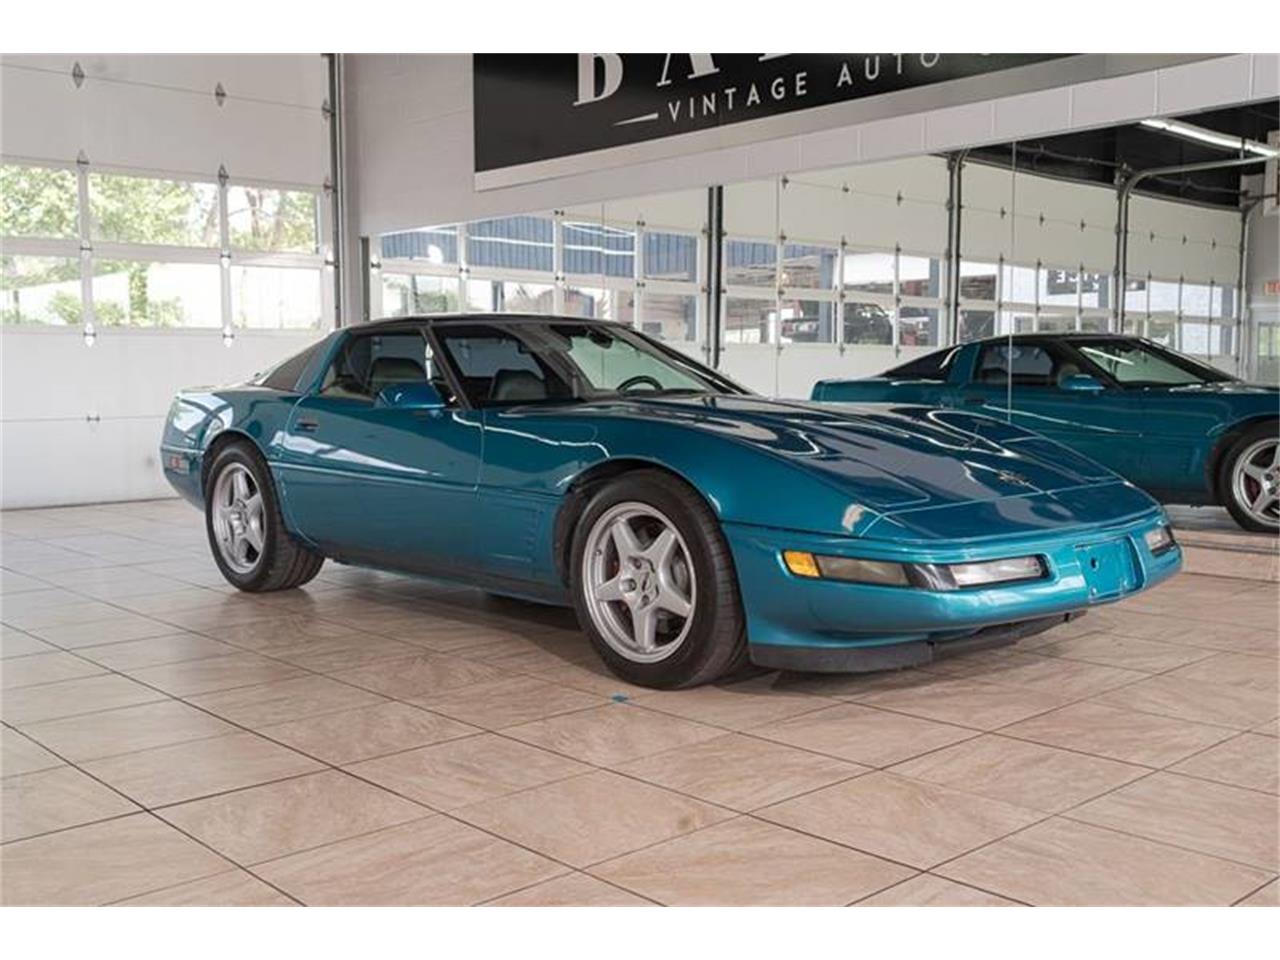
[161,315,1181,687]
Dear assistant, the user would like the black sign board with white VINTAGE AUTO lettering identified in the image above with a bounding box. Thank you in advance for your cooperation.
[472,54,1070,179]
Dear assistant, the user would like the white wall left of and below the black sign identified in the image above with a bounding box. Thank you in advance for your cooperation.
[344,54,1280,236]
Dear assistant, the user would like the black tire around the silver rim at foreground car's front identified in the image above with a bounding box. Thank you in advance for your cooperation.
[570,470,748,690]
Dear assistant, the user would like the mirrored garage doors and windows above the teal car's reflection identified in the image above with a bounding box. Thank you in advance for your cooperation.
[370,102,1280,397]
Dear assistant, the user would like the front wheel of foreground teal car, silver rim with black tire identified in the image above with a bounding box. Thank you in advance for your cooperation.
[571,470,746,689]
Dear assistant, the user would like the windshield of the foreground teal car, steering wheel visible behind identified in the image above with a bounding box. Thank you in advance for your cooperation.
[435,320,744,407]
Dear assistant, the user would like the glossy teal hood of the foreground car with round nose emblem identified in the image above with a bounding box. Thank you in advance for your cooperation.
[581,397,1119,515]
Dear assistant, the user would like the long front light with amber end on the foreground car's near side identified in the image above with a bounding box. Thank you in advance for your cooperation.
[782,550,1047,590]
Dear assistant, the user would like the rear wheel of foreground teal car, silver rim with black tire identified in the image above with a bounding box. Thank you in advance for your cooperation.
[205,442,324,593]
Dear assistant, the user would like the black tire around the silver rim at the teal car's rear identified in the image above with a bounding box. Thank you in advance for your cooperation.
[205,440,324,593]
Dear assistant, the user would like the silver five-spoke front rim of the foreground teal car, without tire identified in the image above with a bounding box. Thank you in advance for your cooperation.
[582,502,698,663]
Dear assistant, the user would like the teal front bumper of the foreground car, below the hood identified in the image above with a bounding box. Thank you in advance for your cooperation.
[724,507,1181,672]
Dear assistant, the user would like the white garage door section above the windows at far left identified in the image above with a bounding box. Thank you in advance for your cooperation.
[0,54,329,187]
